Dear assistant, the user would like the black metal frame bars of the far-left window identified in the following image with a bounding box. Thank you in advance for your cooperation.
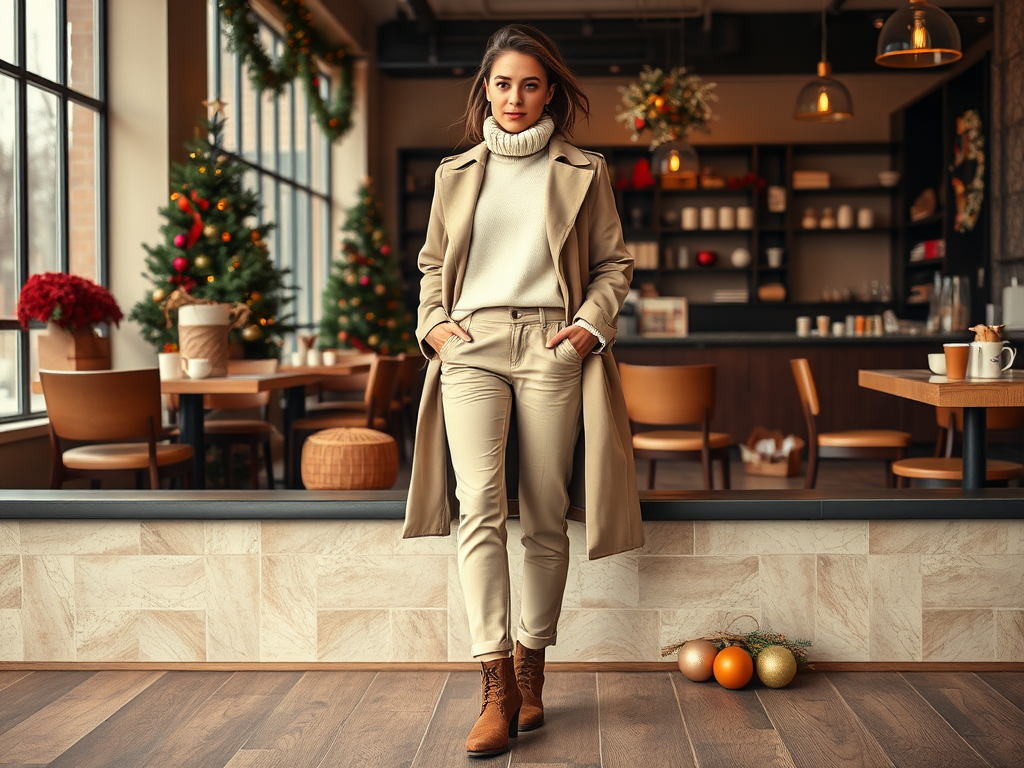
[0,0,110,425]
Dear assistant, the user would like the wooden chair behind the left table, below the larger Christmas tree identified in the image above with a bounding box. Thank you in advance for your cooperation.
[203,359,278,490]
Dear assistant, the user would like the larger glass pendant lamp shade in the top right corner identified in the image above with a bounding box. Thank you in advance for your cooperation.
[874,0,964,68]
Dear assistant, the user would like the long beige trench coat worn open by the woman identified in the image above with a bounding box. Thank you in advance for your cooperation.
[402,136,643,559]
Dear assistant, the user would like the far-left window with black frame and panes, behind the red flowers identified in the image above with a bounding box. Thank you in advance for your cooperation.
[0,0,106,422]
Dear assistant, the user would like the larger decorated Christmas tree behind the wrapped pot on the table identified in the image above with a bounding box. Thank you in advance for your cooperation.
[130,116,292,358]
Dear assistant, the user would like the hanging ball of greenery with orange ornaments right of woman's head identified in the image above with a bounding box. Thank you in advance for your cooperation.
[615,67,718,152]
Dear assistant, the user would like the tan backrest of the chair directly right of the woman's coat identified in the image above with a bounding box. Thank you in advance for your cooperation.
[618,362,716,426]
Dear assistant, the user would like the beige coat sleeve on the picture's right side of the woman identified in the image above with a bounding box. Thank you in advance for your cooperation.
[572,157,633,349]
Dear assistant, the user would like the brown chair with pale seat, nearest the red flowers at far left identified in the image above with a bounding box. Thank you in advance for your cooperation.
[39,369,194,489]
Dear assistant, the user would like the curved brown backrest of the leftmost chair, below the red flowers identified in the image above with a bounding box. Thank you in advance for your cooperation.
[39,368,160,442]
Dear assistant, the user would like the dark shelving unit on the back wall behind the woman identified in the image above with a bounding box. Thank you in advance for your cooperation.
[396,142,898,328]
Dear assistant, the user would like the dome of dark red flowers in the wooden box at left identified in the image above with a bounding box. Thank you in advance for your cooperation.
[17,272,124,331]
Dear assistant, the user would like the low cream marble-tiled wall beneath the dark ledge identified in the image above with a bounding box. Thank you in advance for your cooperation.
[0,520,1024,663]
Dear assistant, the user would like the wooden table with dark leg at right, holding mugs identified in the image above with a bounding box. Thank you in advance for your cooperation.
[857,371,1024,490]
